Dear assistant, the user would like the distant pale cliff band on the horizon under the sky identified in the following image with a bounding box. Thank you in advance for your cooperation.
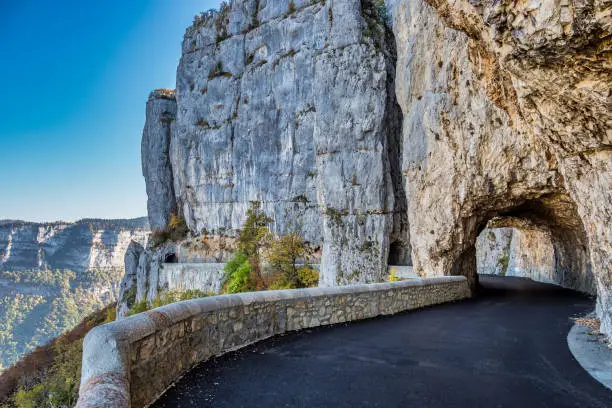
[0,218,149,272]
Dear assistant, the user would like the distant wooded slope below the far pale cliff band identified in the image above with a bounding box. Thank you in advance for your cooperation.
[0,268,123,367]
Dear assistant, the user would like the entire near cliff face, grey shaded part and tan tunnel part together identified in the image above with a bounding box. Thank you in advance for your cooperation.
[131,0,612,333]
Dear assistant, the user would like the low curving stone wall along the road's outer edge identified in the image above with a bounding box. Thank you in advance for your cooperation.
[77,277,470,408]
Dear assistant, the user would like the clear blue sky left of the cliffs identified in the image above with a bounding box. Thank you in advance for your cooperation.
[0,0,219,221]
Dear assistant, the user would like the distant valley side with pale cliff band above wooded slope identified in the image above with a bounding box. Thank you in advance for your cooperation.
[0,218,149,371]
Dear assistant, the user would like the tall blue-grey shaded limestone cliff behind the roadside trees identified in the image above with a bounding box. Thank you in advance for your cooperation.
[143,0,410,285]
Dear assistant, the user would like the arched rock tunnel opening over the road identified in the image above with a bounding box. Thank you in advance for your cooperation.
[452,194,596,294]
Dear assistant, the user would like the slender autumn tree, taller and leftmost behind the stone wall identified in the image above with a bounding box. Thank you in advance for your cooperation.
[237,201,272,289]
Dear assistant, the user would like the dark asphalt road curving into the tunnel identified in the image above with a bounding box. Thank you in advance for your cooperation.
[154,277,612,408]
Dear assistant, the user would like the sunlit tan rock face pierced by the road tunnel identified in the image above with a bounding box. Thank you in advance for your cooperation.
[389,0,612,333]
